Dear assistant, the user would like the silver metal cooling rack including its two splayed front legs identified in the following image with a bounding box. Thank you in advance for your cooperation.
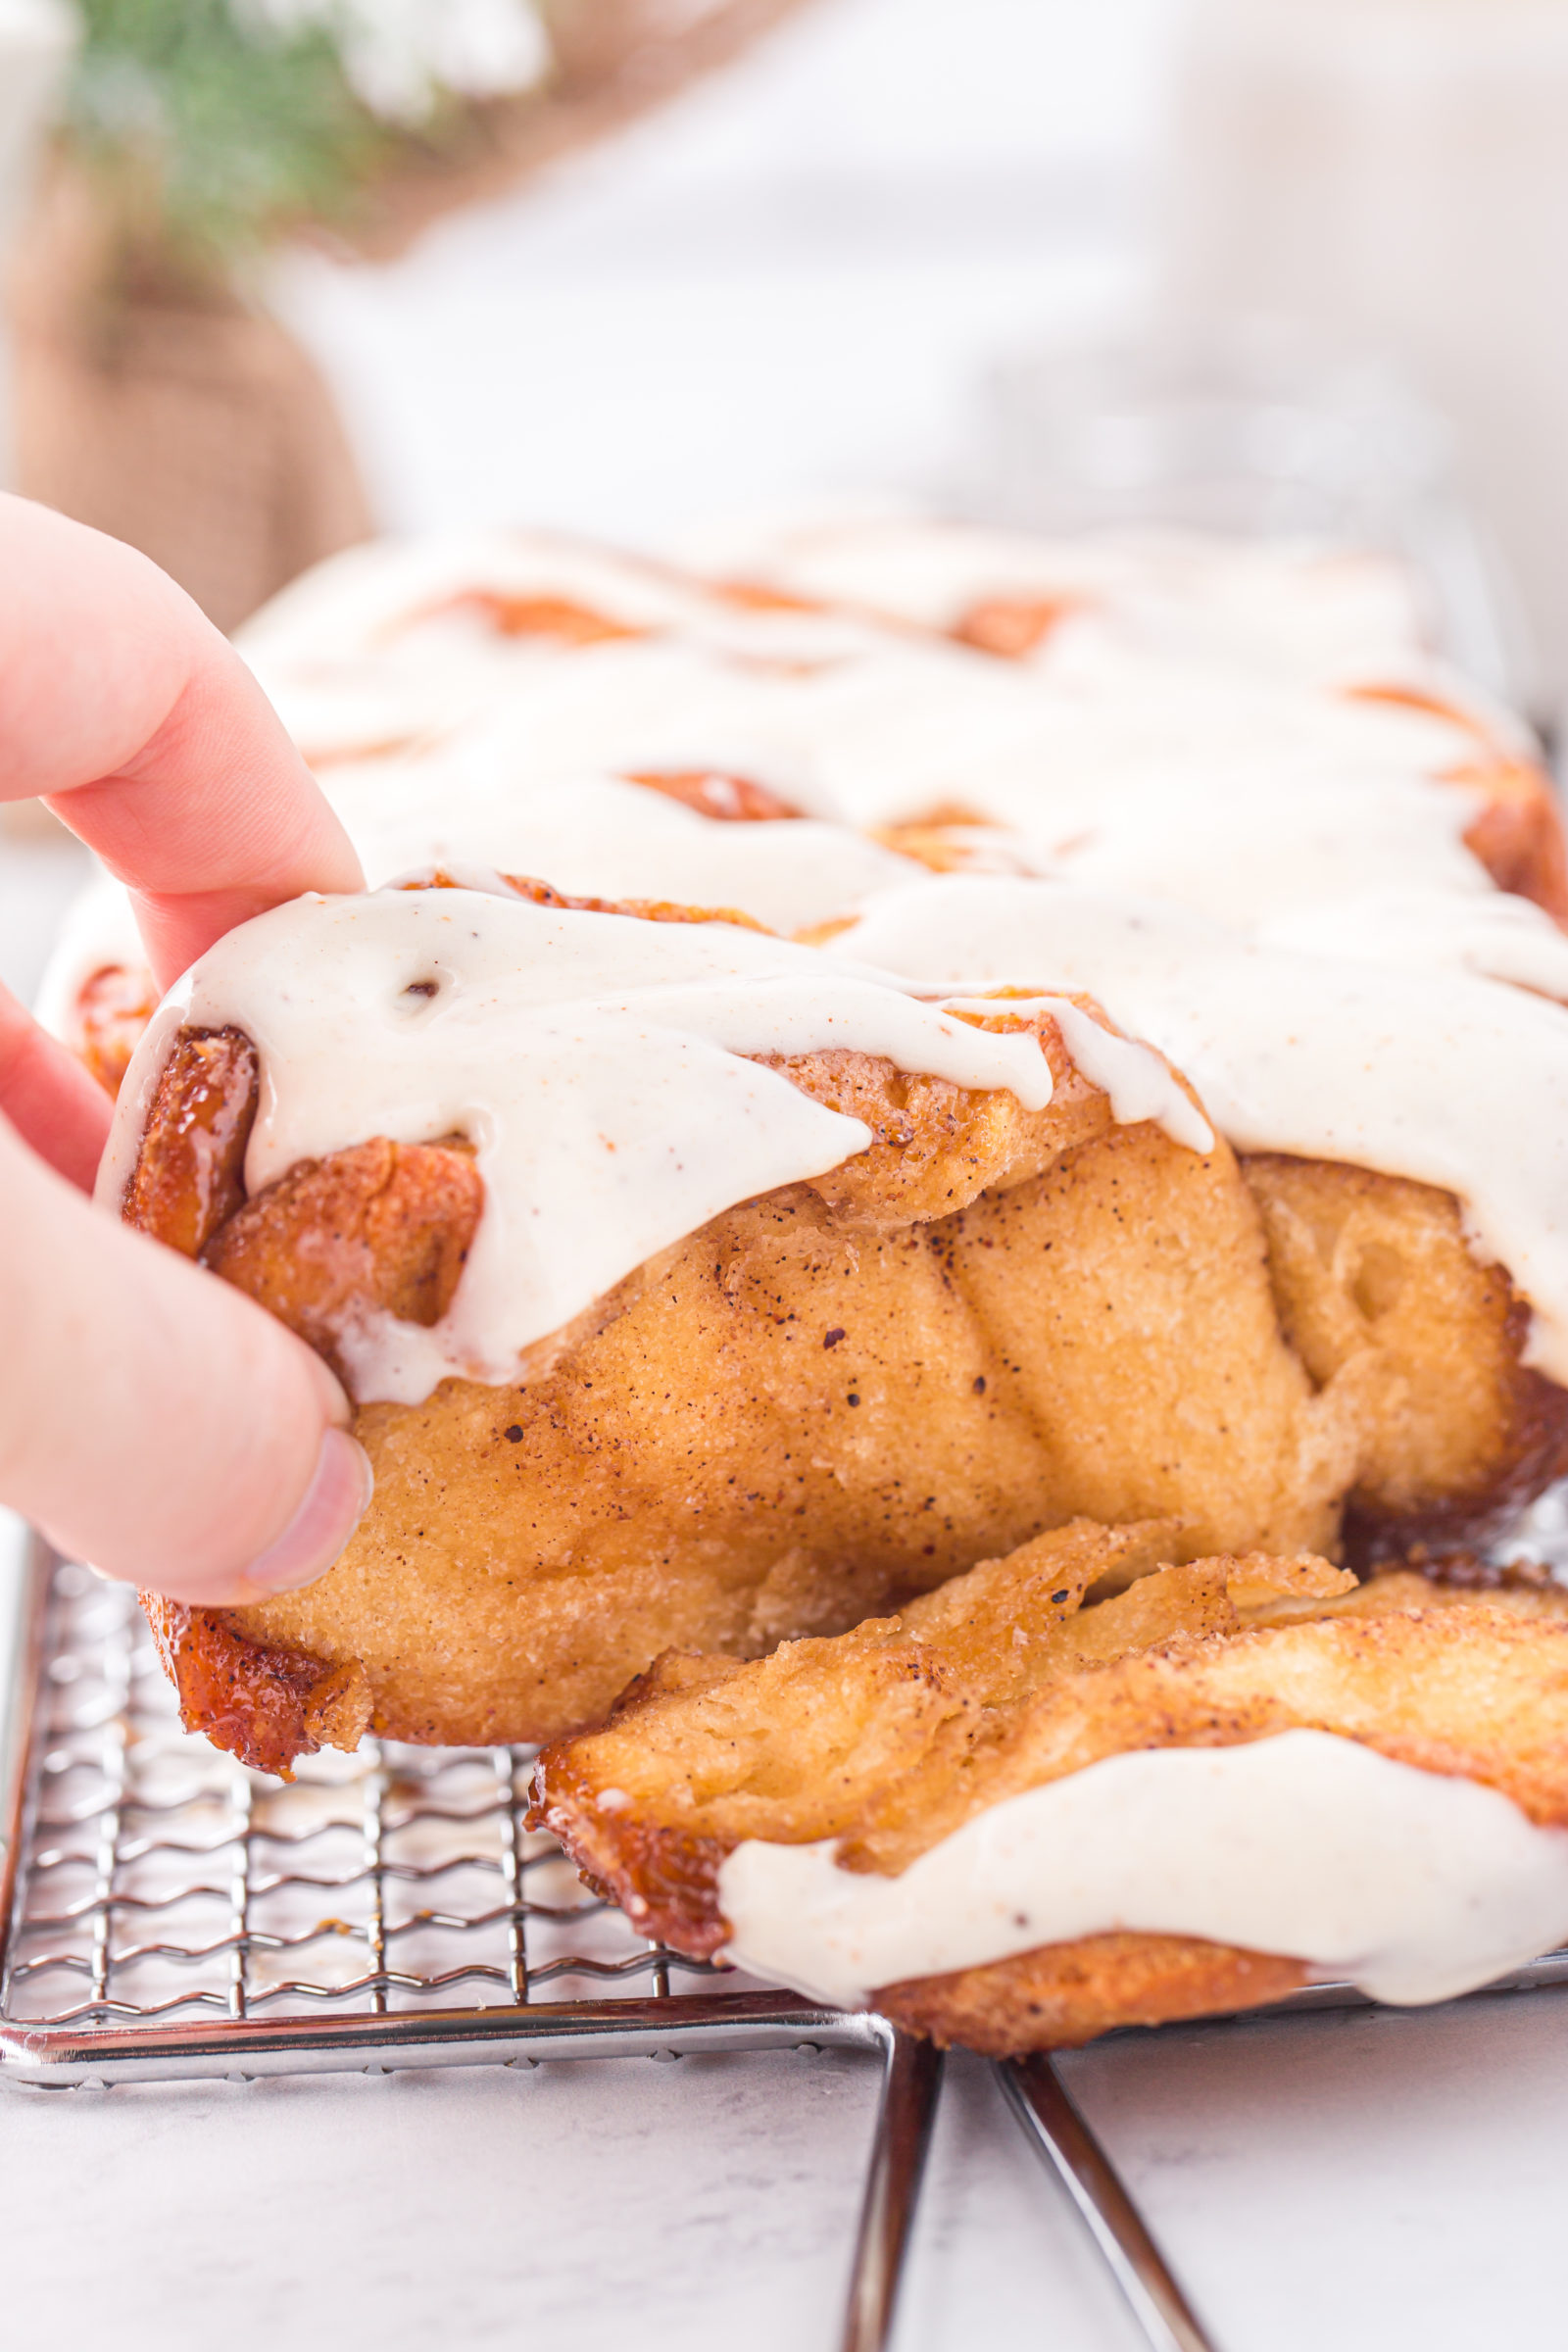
[0,1545,1568,2352]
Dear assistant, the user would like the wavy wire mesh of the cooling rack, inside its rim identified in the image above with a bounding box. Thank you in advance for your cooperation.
[2,1564,712,2033]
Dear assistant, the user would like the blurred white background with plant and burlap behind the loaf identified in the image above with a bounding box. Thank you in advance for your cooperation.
[0,0,1568,706]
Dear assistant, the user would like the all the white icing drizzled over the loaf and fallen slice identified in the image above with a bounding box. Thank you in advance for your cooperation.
[150,519,1568,1999]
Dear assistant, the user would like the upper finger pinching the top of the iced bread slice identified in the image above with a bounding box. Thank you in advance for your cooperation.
[0,496,365,986]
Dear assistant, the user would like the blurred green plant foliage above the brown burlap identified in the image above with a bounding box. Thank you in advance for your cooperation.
[66,0,397,277]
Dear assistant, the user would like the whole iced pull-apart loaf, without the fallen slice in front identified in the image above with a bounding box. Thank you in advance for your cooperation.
[79,524,1568,1796]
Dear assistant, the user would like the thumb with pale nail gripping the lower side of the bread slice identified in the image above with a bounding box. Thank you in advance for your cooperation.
[0,1119,371,1606]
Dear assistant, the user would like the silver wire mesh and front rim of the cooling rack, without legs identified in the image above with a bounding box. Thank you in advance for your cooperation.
[0,1552,874,2083]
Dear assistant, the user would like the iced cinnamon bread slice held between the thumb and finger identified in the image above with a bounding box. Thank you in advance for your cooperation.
[106,882,1354,1766]
